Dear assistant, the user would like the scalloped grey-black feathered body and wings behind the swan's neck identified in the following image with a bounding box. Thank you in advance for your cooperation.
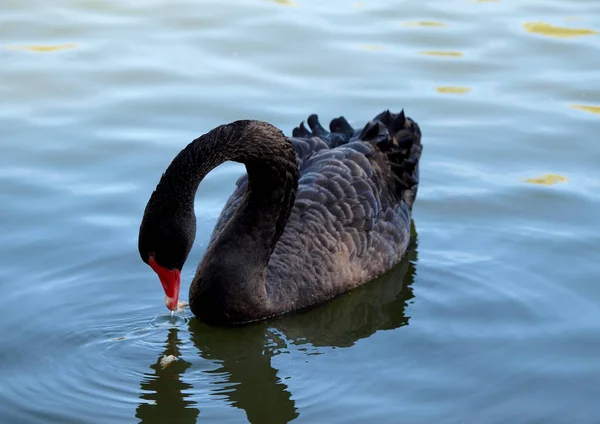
[212,111,422,315]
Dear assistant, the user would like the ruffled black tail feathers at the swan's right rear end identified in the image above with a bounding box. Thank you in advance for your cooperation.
[358,110,423,207]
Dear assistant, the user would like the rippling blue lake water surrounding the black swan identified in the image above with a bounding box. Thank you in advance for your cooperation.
[0,0,600,424]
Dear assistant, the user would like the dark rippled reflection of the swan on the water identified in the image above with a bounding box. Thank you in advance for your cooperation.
[136,227,417,423]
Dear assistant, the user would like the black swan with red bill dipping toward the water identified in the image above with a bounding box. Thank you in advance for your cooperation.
[138,111,422,325]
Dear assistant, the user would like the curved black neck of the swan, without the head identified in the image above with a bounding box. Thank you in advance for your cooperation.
[156,121,298,322]
